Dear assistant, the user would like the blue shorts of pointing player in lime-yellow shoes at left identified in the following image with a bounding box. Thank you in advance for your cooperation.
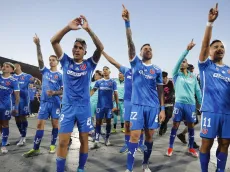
[38,101,60,120]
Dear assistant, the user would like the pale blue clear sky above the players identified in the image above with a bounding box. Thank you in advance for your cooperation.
[0,0,230,77]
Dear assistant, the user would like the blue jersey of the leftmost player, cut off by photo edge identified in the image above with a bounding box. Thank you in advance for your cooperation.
[0,75,20,109]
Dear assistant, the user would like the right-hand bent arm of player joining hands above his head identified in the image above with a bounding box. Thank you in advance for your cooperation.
[80,15,104,63]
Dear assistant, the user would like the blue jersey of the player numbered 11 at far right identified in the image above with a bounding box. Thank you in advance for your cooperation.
[198,58,230,115]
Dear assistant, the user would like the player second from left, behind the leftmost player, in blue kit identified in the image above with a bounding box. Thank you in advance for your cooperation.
[13,63,38,146]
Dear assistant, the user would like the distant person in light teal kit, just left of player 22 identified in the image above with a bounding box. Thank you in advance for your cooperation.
[112,72,125,133]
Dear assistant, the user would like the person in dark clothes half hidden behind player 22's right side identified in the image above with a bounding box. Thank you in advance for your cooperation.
[159,71,175,136]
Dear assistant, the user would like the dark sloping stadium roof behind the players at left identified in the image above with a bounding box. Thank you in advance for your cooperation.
[0,56,42,80]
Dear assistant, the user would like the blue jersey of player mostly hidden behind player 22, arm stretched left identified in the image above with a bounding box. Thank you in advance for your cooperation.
[120,66,132,101]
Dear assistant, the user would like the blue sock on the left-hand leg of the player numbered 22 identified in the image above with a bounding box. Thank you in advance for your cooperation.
[127,142,138,171]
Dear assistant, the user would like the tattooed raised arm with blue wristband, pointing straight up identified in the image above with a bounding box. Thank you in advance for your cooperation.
[122,5,136,60]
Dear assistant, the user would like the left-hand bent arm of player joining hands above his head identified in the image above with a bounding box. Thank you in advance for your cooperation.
[50,18,81,59]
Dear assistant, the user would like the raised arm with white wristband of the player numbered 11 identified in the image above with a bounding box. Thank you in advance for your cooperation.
[199,3,218,62]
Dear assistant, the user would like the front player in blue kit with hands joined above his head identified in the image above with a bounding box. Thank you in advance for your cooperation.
[51,16,104,172]
